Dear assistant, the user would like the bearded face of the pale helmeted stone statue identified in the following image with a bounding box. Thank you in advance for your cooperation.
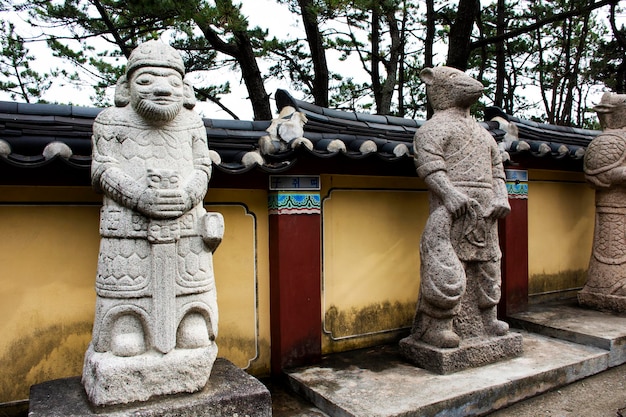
[129,67,184,124]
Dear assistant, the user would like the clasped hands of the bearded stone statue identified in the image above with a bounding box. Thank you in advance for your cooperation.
[137,188,188,219]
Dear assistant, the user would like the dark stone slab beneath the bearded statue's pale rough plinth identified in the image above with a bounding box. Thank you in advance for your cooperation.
[28,358,272,417]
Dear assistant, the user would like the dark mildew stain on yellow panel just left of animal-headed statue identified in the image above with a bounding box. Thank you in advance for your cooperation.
[324,301,415,338]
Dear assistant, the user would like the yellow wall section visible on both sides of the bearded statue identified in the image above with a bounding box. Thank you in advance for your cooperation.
[0,187,270,403]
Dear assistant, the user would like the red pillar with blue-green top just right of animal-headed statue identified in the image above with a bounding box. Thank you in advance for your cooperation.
[498,169,528,317]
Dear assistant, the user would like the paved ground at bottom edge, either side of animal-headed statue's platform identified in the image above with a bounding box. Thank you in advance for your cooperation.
[268,365,626,417]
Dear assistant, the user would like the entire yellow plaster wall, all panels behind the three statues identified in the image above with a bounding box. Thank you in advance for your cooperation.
[0,170,594,403]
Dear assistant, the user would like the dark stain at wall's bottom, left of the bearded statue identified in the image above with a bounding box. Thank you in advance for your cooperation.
[0,322,92,402]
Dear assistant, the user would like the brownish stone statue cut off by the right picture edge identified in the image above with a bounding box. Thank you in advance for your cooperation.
[578,93,626,312]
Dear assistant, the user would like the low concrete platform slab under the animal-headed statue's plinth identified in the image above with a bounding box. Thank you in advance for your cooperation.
[287,330,609,417]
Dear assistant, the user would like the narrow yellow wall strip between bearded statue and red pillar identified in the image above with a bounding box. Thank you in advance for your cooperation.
[206,190,270,375]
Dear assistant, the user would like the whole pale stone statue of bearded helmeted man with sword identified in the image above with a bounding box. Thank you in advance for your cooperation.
[82,41,224,406]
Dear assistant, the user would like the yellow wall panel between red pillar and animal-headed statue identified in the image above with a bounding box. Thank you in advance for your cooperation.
[322,176,428,353]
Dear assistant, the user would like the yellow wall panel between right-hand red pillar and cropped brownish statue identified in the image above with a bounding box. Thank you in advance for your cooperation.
[528,170,595,301]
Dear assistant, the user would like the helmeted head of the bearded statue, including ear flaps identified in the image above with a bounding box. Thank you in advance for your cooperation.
[115,40,195,124]
